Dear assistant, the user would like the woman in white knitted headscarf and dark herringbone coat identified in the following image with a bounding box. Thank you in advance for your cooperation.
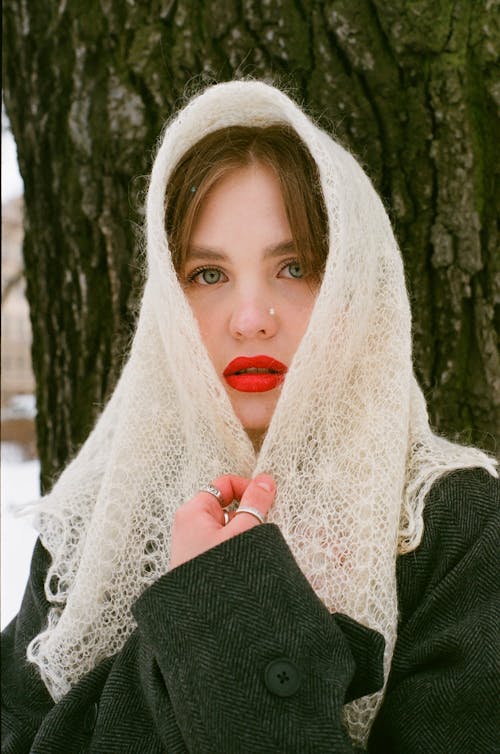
[3,82,498,754]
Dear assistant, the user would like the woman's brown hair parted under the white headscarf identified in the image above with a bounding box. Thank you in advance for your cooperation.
[165,124,328,280]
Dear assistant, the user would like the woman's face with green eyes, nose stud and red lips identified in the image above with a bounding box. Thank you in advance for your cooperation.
[181,163,316,445]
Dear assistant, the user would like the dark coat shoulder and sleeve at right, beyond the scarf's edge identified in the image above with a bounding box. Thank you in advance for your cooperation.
[369,469,500,754]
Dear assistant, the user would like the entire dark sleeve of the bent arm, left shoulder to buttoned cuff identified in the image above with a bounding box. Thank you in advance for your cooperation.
[2,524,384,754]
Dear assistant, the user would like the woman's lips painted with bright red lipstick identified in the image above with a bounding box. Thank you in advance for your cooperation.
[223,356,287,393]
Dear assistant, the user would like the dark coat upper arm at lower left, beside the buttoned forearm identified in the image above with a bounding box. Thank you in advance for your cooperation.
[1,541,180,754]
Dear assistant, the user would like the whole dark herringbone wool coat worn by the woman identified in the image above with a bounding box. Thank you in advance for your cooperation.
[2,470,500,754]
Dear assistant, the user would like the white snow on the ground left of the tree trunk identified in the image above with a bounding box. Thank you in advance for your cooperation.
[1,443,40,628]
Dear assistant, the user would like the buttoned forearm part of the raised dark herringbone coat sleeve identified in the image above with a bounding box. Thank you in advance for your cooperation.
[134,524,384,754]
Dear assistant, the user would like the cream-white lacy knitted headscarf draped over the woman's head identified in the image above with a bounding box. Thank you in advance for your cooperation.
[28,81,496,745]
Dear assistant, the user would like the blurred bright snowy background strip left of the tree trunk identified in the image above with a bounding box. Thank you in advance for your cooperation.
[1,103,40,628]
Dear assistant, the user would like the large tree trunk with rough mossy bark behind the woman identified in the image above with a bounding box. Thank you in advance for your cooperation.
[4,0,500,489]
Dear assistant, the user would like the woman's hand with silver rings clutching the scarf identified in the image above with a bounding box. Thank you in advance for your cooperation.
[170,474,276,568]
